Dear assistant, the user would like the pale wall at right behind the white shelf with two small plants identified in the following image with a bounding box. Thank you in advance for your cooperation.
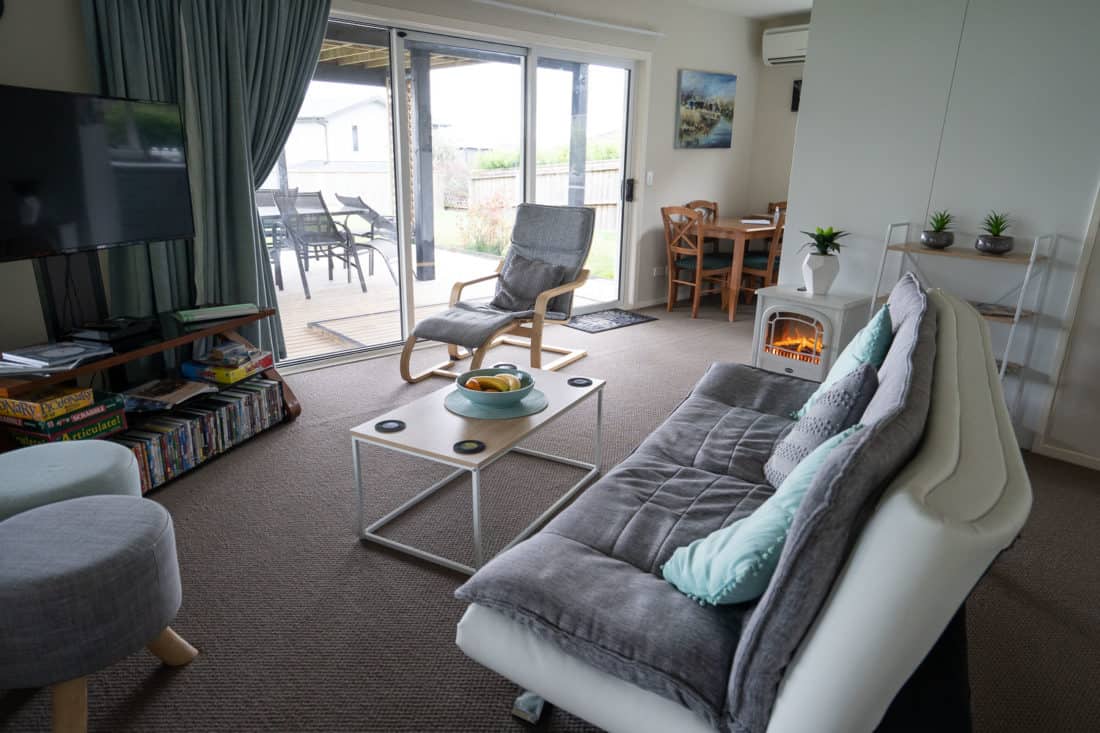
[780,0,1100,445]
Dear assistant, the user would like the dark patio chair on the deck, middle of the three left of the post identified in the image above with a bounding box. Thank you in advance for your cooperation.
[275,192,366,299]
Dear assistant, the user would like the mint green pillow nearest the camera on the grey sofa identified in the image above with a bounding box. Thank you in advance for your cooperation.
[661,425,862,605]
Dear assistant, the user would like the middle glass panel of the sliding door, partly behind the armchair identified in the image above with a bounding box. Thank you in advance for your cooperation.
[402,33,526,319]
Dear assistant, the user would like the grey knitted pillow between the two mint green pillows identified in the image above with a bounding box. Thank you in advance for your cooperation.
[763,364,879,489]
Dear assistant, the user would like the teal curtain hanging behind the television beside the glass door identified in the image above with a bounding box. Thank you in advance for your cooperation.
[85,0,330,355]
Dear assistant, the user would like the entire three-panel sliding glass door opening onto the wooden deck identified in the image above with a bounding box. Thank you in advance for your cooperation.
[256,20,630,360]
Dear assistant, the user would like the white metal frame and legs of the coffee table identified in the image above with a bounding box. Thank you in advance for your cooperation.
[351,384,605,576]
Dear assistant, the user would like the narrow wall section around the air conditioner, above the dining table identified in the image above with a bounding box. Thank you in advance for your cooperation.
[748,13,810,211]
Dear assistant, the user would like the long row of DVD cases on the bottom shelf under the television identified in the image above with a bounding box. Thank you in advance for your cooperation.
[112,378,283,492]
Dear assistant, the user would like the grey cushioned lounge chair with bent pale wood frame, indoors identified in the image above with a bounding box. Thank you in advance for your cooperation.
[400,204,596,384]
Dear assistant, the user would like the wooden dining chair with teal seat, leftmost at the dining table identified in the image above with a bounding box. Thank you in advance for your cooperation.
[661,206,733,318]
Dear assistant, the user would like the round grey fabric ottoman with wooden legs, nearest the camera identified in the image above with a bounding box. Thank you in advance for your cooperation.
[0,496,198,731]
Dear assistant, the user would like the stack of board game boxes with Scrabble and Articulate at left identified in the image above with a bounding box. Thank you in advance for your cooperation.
[0,387,127,446]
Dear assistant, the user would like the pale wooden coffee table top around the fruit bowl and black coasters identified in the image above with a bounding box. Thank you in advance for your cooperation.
[351,368,606,469]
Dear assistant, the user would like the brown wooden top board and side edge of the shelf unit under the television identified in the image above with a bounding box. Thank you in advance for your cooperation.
[0,308,301,420]
